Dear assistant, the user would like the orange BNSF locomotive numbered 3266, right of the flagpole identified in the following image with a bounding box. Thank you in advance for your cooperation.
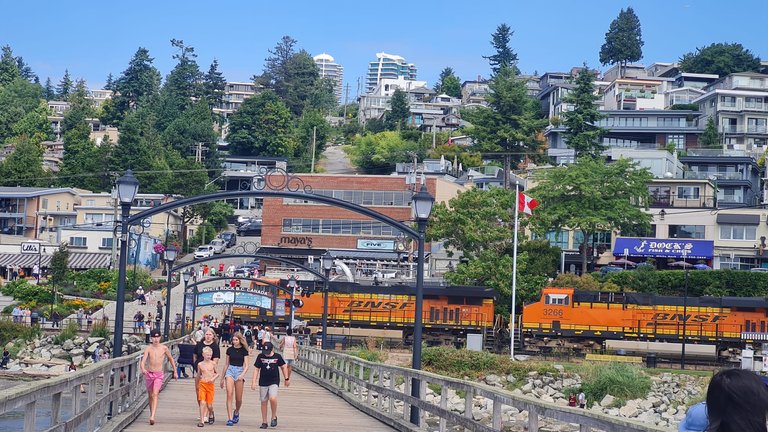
[521,287,768,358]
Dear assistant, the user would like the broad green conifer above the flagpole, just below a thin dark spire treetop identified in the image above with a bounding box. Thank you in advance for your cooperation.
[464,67,547,164]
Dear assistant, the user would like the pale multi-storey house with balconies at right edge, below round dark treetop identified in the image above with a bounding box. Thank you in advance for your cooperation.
[692,72,768,157]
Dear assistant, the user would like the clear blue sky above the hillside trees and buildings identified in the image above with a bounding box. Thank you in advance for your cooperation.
[0,0,768,98]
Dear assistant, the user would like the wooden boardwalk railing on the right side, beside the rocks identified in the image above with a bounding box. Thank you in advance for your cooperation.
[295,347,671,432]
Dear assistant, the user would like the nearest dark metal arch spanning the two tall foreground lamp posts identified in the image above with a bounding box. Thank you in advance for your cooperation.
[125,190,419,240]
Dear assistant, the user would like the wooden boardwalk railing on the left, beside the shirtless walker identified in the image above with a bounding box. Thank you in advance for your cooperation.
[0,340,180,432]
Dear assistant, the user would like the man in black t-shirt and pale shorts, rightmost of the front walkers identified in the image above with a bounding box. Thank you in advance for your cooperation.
[251,342,290,429]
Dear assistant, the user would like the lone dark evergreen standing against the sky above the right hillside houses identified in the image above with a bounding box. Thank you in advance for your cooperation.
[600,7,644,77]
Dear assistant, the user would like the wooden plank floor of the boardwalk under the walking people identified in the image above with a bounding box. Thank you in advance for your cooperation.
[125,362,394,432]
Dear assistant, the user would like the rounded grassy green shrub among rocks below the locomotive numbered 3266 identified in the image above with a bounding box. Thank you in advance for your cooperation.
[579,363,651,405]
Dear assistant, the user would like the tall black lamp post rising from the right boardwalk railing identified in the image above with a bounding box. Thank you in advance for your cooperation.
[411,184,435,425]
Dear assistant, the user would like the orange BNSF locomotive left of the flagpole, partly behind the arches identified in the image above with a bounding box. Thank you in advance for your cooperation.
[232,280,497,344]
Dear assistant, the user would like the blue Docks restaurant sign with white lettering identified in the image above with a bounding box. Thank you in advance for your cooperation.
[613,237,715,260]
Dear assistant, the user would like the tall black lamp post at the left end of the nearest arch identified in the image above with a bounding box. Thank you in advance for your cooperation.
[112,170,139,357]
